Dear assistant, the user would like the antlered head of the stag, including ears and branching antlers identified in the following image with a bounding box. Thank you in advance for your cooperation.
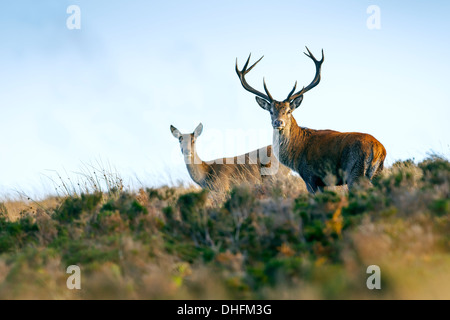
[236,47,324,131]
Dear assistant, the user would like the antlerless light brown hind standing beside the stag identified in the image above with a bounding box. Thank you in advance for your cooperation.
[171,124,290,191]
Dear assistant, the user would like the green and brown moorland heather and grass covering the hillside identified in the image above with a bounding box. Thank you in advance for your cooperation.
[0,156,450,299]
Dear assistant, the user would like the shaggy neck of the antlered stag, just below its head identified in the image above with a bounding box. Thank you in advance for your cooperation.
[273,118,309,170]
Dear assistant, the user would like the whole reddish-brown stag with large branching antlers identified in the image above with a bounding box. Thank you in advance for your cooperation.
[236,47,386,193]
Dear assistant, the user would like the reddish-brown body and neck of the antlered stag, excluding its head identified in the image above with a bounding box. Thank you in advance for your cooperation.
[273,118,386,192]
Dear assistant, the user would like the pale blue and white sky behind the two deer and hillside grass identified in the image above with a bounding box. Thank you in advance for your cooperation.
[0,0,450,198]
